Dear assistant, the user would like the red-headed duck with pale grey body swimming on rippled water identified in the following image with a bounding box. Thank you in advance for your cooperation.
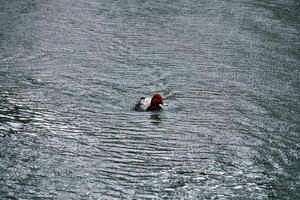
[135,93,164,112]
